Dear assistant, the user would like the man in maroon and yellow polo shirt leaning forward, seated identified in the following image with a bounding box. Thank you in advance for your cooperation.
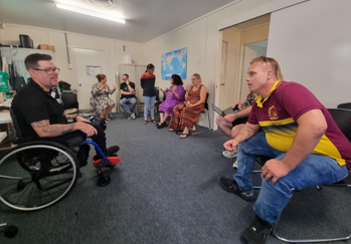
[220,56,351,244]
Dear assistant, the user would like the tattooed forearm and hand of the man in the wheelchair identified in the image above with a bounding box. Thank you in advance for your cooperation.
[31,120,97,137]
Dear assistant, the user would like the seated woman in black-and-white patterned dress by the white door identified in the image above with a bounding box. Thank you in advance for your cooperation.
[90,74,118,121]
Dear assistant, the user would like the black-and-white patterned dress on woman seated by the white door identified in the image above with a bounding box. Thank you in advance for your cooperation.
[90,83,116,116]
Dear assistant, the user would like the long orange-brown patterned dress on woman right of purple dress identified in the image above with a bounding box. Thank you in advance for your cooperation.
[169,85,205,131]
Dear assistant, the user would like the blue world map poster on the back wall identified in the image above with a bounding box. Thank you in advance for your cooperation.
[161,47,188,80]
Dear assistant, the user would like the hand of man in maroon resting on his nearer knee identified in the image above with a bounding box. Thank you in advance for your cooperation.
[262,159,290,185]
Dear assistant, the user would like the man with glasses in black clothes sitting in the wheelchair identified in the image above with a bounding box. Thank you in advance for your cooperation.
[11,53,119,166]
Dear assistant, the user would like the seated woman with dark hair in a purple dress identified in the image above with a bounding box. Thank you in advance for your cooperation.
[156,75,185,129]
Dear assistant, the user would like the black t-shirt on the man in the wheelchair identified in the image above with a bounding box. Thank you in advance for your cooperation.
[11,79,67,138]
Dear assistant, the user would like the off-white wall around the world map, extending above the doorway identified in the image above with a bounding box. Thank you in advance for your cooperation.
[144,0,277,125]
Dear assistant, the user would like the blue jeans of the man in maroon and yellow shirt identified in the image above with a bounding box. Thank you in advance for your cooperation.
[233,132,349,224]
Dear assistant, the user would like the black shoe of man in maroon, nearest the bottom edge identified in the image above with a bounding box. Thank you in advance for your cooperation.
[240,216,273,244]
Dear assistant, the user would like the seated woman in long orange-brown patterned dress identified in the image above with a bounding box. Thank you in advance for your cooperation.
[169,73,207,139]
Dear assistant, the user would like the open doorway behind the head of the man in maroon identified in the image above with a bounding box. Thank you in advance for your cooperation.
[216,14,270,110]
